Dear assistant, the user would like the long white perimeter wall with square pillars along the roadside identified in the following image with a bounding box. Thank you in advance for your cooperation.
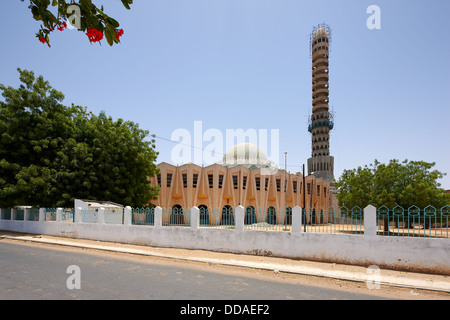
[0,206,450,274]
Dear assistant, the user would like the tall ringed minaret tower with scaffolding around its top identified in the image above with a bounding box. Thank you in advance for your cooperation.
[308,25,334,182]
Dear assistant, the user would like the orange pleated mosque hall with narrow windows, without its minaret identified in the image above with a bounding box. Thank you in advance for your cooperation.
[150,144,334,222]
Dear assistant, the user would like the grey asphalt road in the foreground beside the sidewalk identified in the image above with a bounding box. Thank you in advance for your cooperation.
[0,241,394,301]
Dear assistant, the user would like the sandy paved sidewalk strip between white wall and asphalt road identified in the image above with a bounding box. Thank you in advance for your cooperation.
[0,231,450,293]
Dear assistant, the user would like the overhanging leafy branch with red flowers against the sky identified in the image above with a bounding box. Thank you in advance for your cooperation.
[22,0,133,46]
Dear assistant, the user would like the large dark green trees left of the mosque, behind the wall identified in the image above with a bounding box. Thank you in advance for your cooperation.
[0,69,159,207]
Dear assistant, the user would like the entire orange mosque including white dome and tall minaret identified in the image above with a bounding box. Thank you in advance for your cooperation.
[150,25,336,224]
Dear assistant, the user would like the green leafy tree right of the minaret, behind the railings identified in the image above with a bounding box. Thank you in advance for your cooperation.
[336,160,449,208]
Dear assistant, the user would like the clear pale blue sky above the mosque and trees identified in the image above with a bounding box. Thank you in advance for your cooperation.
[0,0,450,189]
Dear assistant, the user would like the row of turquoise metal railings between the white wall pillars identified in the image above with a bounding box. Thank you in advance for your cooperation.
[1,205,450,238]
